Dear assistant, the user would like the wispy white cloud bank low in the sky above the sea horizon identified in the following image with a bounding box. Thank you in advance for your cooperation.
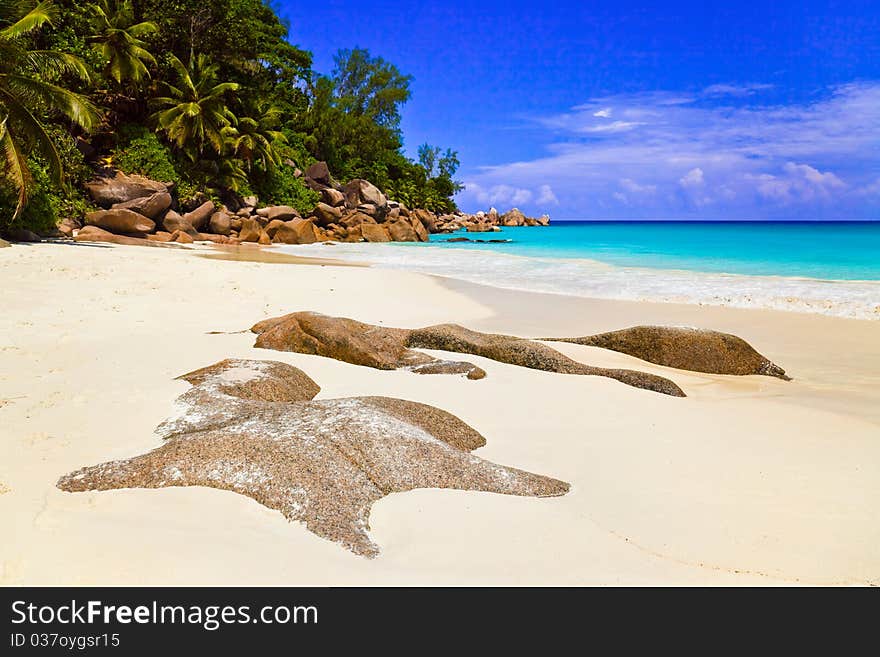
[458,82,880,219]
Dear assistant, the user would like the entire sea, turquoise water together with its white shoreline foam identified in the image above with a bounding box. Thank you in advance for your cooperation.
[282,221,880,319]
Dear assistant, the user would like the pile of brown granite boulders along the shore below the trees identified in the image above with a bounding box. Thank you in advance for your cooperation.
[59,162,550,245]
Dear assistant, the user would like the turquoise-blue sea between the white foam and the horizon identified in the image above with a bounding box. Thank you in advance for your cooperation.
[431,221,880,280]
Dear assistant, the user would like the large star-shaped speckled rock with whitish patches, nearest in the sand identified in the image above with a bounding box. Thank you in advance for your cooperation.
[58,359,569,557]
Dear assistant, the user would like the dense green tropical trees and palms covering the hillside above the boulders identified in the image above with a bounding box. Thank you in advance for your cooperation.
[0,0,459,236]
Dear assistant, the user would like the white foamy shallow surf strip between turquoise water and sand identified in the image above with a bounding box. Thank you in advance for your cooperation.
[280,243,880,320]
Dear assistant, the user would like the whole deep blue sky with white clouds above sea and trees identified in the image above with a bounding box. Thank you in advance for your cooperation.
[273,0,880,220]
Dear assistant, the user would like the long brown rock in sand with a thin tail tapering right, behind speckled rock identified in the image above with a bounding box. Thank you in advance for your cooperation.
[251,312,685,397]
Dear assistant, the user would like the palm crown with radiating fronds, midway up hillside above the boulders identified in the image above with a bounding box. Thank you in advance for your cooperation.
[153,55,239,162]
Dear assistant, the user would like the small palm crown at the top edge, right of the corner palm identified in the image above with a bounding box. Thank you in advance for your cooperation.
[89,0,159,85]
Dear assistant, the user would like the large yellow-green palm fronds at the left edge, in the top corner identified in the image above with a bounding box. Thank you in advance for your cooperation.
[0,0,98,219]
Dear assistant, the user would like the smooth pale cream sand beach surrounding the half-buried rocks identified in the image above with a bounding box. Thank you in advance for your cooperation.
[0,244,880,586]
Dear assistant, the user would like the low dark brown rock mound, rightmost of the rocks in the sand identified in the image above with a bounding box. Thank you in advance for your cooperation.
[547,326,791,381]
